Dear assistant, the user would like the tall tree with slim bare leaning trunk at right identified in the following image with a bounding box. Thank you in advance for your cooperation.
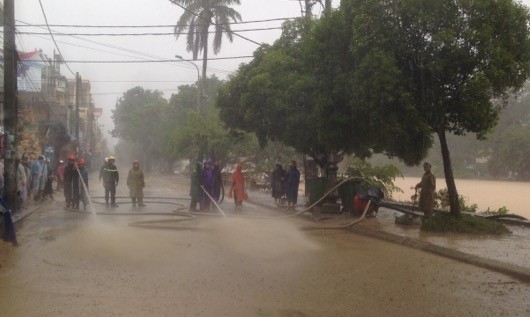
[341,0,530,216]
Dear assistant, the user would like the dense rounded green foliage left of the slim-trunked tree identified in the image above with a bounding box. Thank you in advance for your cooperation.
[217,12,431,167]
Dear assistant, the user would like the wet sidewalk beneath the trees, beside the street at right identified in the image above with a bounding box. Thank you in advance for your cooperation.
[245,186,530,282]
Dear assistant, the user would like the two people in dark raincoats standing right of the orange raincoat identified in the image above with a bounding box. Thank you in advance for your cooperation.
[271,160,300,210]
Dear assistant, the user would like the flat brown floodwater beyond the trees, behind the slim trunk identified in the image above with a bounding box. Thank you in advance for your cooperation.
[394,177,530,219]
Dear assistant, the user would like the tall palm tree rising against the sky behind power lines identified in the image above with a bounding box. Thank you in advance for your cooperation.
[169,0,241,114]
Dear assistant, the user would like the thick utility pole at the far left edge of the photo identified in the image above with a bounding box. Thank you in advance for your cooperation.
[3,0,17,210]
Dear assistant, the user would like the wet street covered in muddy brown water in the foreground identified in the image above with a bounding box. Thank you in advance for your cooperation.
[0,174,530,316]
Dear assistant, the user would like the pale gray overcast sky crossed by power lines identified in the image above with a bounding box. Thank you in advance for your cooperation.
[15,0,318,146]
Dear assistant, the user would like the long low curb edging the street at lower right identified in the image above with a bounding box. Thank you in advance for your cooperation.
[350,226,530,283]
